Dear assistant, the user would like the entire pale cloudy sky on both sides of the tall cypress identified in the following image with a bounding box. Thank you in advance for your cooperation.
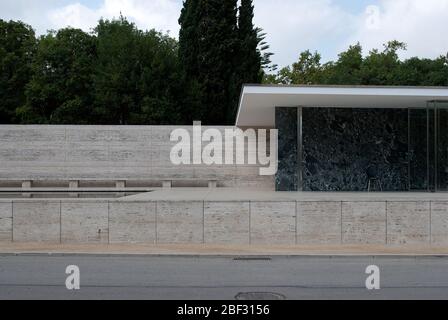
[0,0,448,67]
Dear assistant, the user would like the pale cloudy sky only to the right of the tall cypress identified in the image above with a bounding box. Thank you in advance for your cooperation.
[255,0,448,66]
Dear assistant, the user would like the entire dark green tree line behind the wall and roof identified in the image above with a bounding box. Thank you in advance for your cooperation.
[0,10,448,125]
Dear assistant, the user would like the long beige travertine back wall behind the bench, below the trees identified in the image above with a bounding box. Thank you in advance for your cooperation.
[0,125,275,190]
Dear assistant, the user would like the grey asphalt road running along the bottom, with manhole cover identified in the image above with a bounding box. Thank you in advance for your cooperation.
[0,255,448,300]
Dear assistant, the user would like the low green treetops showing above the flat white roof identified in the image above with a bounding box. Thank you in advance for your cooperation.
[264,41,448,86]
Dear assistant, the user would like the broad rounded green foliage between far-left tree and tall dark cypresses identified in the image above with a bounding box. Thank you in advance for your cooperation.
[6,17,192,124]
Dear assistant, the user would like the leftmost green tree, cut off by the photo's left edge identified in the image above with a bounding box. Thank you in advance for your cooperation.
[0,20,36,124]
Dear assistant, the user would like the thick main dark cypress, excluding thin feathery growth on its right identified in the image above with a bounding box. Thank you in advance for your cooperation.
[179,0,242,125]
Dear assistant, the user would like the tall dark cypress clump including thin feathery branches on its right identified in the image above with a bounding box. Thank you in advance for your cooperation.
[179,0,269,124]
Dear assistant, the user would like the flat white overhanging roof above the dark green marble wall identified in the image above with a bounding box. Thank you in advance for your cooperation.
[236,85,448,128]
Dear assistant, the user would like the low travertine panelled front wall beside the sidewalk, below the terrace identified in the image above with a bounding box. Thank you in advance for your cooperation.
[0,199,448,246]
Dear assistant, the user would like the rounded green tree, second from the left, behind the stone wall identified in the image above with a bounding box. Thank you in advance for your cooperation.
[18,28,96,124]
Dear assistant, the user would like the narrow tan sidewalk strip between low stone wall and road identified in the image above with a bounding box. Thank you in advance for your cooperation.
[0,242,448,257]
